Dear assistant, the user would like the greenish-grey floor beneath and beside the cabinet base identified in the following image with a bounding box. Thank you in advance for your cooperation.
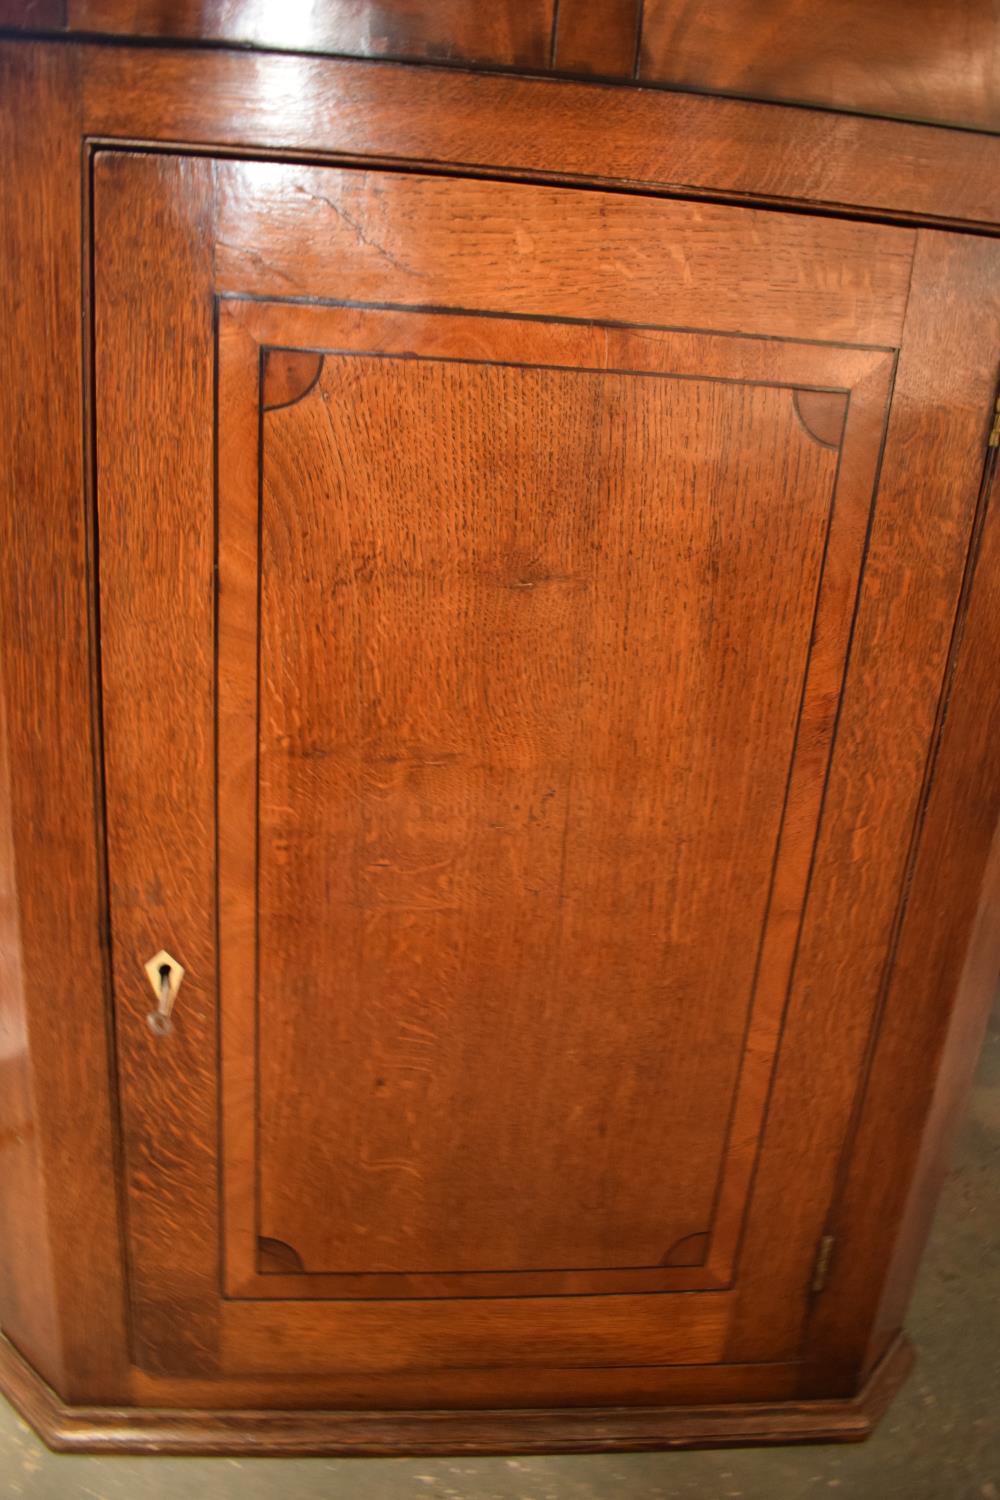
[0,996,1000,1500]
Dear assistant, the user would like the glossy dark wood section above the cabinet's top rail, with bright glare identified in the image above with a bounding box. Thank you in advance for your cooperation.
[0,0,1000,132]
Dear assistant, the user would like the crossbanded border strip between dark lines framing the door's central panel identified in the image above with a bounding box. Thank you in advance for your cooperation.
[216,296,895,1299]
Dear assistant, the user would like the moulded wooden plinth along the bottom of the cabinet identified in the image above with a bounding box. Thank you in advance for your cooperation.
[0,1335,913,1457]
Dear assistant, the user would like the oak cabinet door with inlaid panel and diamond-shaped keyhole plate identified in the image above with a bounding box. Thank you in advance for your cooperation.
[94,153,930,1403]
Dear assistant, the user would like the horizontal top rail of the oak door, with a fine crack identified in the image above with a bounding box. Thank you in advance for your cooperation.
[216,162,913,347]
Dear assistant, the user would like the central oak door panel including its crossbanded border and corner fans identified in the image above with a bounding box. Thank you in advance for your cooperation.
[219,300,891,1296]
